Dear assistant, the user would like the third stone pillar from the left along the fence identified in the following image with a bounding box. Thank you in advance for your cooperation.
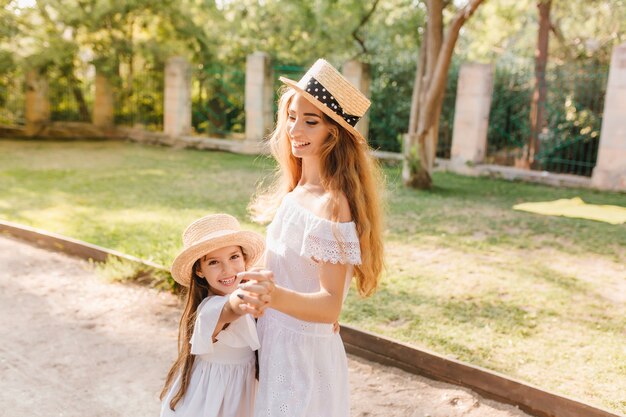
[163,57,191,137]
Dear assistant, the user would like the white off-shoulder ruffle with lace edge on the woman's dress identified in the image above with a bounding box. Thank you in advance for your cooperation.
[268,194,361,265]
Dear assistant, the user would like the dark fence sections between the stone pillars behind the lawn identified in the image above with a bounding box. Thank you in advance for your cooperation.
[0,55,608,176]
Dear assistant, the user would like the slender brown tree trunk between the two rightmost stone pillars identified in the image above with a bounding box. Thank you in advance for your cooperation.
[523,0,552,168]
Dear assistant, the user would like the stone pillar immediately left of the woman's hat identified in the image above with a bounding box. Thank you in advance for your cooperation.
[245,52,274,147]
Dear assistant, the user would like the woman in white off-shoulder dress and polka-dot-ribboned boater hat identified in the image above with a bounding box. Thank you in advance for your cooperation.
[244,60,383,417]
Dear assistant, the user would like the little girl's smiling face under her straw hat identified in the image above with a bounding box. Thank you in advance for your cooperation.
[196,246,246,295]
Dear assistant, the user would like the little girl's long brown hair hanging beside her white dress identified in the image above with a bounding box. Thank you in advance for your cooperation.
[160,262,210,411]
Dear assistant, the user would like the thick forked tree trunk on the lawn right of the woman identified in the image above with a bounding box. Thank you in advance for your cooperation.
[402,0,484,188]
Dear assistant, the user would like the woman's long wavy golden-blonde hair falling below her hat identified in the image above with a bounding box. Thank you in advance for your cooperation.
[249,89,383,297]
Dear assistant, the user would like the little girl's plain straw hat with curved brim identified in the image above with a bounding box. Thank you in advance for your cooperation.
[171,214,265,287]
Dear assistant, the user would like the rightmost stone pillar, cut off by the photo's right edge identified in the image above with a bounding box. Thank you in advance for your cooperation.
[591,43,626,191]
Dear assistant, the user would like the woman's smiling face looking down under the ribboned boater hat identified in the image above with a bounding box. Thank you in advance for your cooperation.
[287,94,330,158]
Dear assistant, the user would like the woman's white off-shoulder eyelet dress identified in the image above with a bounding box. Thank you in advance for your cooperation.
[254,194,361,417]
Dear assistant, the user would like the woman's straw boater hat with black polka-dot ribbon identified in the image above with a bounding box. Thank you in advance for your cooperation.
[280,59,370,141]
